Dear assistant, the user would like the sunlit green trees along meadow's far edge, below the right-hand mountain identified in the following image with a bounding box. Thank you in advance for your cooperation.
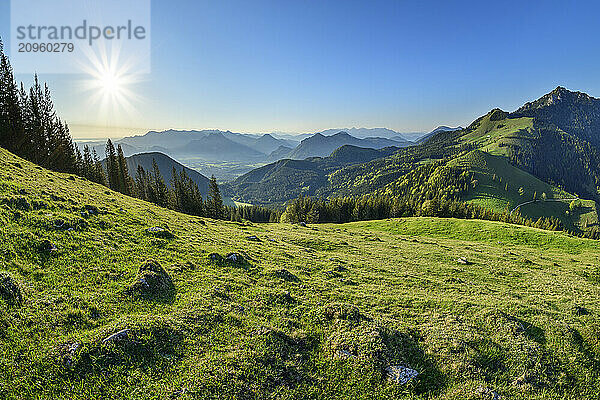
[281,160,564,230]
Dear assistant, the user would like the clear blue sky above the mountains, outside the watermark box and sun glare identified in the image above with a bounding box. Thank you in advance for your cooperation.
[0,0,600,135]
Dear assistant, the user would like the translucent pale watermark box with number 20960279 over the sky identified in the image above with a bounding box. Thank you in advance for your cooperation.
[10,0,151,74]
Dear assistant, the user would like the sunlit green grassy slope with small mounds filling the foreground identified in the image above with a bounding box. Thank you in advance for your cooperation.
[0,150,600,399]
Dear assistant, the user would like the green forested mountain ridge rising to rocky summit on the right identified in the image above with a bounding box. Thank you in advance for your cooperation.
[228,87,600,230]
